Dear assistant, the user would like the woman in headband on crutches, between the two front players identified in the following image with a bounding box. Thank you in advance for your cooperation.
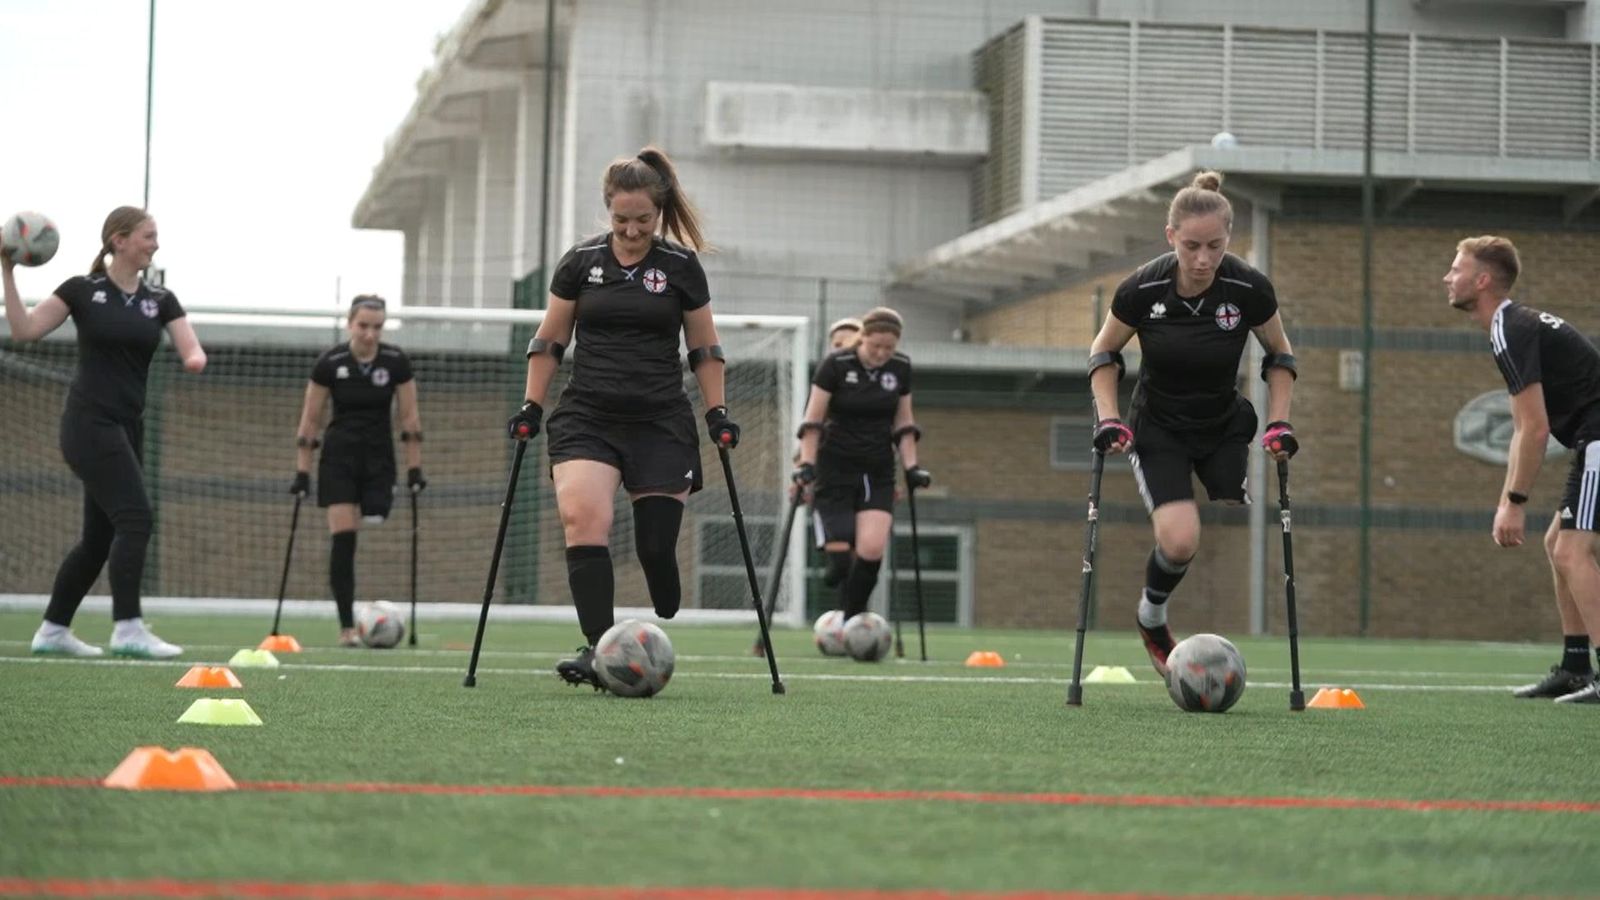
[794,307,933,620]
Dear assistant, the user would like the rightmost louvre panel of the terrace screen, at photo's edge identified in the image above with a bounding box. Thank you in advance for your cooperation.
[1506,42,1592,159]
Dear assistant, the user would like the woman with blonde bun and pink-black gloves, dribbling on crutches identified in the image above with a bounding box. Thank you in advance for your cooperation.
[1088,171,1299,677]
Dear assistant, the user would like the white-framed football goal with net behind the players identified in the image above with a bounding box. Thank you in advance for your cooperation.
[0,306,808,625]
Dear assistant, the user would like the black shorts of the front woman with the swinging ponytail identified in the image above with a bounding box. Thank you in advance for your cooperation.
[544,402,704,493]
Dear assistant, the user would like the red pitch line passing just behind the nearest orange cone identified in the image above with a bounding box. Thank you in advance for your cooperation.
[0,775,1600,812]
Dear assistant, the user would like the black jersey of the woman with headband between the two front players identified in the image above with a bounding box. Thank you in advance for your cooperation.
[811,348,910,463]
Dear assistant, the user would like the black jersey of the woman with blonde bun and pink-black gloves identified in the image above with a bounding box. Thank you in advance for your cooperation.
[1110,253,1278,431]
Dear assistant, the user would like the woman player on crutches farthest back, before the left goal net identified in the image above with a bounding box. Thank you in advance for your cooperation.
[290,295,427,647]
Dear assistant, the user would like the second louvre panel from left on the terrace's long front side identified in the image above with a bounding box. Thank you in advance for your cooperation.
[1133,26,1222,160]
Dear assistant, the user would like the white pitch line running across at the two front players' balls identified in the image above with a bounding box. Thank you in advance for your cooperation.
[0,657,1515,693]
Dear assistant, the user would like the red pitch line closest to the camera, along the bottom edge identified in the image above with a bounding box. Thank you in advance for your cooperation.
[0,878,1529,900]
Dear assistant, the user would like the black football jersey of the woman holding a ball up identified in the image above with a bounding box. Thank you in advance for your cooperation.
[56,275,184,421]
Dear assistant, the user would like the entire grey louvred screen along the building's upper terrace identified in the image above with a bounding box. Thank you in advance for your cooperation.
[973,19,1597,209]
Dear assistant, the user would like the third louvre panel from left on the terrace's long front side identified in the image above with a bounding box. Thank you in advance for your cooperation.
[1229,29,1317,147]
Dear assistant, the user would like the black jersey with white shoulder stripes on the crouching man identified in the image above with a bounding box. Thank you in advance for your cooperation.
[1490,299,1600,447]
